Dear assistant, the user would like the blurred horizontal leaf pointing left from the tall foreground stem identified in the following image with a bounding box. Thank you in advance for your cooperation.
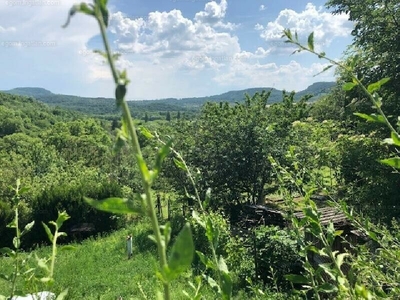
[84,197,144,214]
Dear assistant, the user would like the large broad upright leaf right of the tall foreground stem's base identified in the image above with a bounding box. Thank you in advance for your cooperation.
[168,223,194,281]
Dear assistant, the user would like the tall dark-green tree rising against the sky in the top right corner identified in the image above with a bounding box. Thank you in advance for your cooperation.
[326,0,400,116]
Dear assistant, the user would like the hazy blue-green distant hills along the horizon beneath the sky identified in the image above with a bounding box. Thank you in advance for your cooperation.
[4,82,336,117]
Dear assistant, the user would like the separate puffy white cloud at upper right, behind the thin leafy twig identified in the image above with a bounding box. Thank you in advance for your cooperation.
[255,3,352,48]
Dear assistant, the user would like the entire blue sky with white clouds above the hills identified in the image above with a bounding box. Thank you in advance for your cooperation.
[0,0,352,99]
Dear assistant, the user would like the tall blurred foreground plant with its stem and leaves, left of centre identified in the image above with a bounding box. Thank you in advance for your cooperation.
[63,0,194,300]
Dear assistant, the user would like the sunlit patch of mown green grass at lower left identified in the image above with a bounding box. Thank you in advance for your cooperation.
[0,221,215,300]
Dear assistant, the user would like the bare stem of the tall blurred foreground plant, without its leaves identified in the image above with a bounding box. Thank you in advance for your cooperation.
[95,7,171,300]
